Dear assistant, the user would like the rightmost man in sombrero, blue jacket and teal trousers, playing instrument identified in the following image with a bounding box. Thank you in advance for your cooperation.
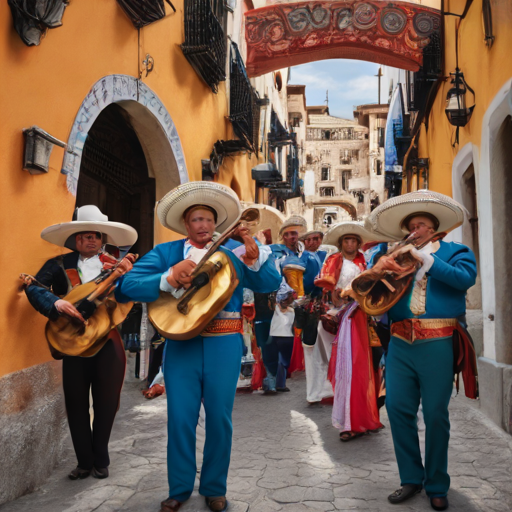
[352,190,478,510]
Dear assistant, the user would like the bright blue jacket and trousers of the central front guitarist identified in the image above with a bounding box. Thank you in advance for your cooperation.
[116,240,281,502]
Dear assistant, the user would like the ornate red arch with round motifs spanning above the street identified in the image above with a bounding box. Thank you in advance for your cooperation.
[245,0,442,76]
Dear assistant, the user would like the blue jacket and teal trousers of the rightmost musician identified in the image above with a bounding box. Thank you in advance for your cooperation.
[386,242,477,498]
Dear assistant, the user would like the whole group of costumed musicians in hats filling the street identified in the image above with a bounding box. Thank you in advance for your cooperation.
[23,182,478,512]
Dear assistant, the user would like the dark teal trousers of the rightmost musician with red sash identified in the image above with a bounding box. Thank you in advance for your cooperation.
[386,337,453,497]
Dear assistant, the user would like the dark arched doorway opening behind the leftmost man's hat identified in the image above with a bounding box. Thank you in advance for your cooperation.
[76,103,156,255]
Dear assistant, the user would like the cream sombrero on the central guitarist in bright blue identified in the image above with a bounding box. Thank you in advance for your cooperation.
[156,181,242,235]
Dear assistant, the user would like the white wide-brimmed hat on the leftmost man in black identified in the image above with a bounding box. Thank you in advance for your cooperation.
[41,204,138,251]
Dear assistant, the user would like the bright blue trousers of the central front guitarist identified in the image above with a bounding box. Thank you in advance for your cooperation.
[164,334,242,501]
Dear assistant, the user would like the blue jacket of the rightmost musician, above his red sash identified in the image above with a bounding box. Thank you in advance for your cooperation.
[389,241,477,322]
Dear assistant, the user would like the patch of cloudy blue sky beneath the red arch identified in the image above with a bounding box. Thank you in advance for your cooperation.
[289,59,387,119]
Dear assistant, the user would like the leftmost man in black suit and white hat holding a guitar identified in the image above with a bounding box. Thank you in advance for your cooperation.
[25,205,137,480]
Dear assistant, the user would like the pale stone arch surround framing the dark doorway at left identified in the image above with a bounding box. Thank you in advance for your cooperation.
[61,75,188,199]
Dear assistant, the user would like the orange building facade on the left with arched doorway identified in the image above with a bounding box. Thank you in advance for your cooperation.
[0,0,298,504]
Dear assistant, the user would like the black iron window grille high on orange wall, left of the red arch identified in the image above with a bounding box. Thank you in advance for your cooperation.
[181,0,226,93]
